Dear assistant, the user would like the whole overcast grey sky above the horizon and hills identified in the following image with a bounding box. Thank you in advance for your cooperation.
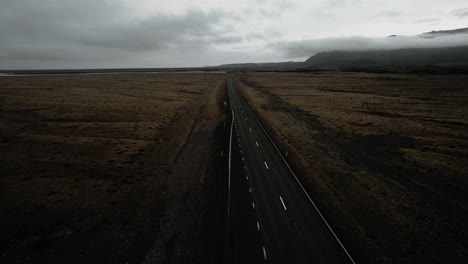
[0,0,468,69]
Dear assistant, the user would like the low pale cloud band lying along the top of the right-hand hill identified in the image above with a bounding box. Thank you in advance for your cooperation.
[274,34,468,58]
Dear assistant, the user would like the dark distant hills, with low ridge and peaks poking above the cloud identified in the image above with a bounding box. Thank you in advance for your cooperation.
[216,28,468,70]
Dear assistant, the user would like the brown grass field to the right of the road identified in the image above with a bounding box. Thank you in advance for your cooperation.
[238,72,468,263]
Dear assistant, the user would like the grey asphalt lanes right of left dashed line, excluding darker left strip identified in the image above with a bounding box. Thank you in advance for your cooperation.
[228,77,354,263]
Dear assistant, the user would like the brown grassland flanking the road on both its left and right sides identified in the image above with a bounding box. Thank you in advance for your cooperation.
[0,72,468,263]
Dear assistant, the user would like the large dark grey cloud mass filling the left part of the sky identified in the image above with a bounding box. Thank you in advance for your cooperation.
[0,0,241,66]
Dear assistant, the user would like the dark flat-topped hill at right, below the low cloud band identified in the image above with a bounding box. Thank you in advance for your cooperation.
[304,46,468,67]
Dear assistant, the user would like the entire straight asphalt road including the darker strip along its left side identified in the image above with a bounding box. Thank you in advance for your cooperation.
[228,76,355,264]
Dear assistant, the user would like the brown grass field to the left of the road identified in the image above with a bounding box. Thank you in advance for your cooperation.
[0,73,226,263]
